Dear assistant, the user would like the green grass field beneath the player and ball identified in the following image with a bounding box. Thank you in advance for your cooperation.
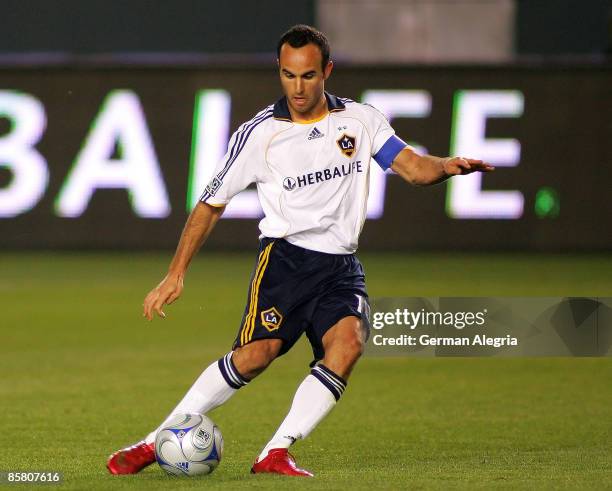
[0,253,612,490]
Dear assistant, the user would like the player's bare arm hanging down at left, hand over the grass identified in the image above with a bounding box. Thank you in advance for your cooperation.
[143,202,225,320]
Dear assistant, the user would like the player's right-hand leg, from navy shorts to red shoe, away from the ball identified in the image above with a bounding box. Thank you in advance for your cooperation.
[252,248,369,476]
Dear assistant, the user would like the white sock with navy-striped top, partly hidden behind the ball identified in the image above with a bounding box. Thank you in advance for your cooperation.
[145,352,248,443]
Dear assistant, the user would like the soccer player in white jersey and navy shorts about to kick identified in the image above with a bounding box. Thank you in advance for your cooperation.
[107,25,493,476]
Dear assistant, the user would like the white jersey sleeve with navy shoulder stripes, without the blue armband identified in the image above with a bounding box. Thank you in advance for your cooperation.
[200,123,259,206]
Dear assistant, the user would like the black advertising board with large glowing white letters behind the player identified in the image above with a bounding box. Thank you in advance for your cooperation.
[0,66,612,251]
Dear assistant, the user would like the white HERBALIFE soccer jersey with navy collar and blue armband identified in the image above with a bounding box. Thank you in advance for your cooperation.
[200,93,406,254]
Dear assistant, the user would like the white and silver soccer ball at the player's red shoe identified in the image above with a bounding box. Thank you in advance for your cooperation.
[155,414,223,476]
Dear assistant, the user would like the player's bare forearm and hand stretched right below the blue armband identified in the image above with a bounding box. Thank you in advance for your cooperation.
[391,147,495,186]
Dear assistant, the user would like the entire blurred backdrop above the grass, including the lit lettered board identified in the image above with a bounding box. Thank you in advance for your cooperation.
[0,0,612,252]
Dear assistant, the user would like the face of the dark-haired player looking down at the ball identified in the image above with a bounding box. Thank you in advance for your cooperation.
[278,43,333,119]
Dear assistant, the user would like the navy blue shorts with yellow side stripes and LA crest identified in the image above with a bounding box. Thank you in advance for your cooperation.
[233,238,370,360]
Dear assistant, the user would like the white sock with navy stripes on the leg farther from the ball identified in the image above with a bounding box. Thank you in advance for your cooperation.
[257,365,346,461]
